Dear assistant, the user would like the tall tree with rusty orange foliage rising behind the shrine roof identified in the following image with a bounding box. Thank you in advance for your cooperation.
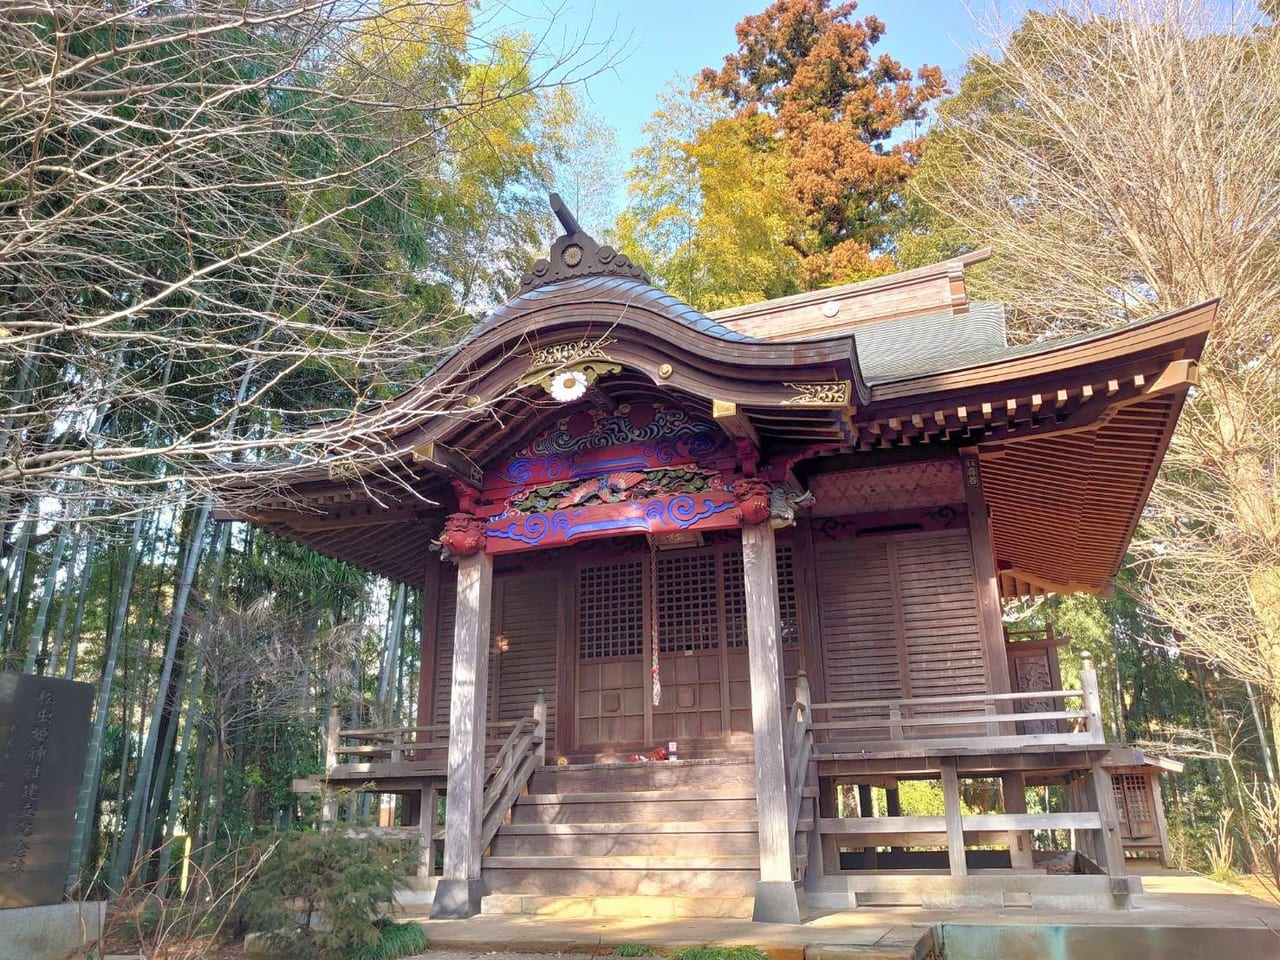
[700,0,947,288]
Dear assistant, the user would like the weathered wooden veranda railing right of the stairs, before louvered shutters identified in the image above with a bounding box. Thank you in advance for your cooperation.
[812,654,1106,755]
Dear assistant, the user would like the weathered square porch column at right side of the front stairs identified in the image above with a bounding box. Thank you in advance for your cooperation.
[742,521,805,923]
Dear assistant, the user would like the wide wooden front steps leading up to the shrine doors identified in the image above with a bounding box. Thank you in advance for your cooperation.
[483,759,813,916]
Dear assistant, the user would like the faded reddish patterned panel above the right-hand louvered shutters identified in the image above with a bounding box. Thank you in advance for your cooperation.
[809,460,964,517]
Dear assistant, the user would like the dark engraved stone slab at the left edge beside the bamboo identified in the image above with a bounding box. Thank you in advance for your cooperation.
[0,673,93,908]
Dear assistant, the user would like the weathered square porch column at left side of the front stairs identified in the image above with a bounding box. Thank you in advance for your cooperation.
[431,550,493,919]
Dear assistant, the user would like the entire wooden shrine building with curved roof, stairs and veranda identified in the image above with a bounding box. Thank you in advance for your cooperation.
[221,204,1216,922]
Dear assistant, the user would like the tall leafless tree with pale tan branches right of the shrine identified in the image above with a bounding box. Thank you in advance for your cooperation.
[915,0,1280,732]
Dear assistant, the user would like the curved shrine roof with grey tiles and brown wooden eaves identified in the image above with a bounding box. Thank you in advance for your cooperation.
[220,224,1216,595]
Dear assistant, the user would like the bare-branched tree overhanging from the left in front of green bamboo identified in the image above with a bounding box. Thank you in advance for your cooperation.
[0,0,612,520]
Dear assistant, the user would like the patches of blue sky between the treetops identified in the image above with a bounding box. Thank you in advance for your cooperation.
[508,0,1025,157]
